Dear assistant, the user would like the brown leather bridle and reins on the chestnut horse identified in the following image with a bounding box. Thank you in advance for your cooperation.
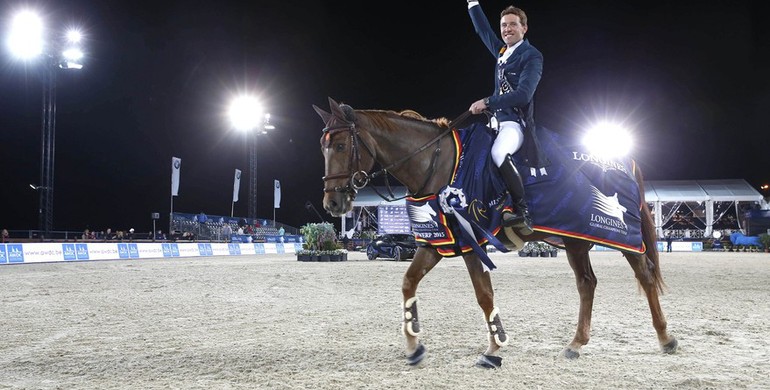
[321,111,471,201]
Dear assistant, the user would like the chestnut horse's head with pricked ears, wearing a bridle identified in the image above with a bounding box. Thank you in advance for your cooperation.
[313,98,374,217]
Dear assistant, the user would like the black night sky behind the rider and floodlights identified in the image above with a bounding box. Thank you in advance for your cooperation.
[0,0,770,231]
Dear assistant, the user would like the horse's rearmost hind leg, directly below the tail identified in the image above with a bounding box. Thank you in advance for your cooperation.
[623,253,678,354]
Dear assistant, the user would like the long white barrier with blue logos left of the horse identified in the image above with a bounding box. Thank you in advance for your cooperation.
[0,242,302,265]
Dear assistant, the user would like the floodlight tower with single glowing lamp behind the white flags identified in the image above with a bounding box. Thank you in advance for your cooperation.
[229,96,275,220]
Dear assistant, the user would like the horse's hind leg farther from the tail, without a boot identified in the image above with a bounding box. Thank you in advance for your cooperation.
[562,240,597,359]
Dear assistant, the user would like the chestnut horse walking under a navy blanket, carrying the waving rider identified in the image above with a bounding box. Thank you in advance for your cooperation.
[313,98,677,368]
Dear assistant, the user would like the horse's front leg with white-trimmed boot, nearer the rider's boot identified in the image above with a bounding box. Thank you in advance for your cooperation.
[463,255,508,368]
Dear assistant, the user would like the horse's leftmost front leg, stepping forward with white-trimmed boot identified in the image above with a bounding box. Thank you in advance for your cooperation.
[401,247,441,366]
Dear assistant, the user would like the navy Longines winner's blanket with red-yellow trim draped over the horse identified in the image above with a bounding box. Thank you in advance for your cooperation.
[406,124,644,269]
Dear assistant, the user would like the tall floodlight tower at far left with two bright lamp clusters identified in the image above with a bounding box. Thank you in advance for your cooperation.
[7,11,83,237]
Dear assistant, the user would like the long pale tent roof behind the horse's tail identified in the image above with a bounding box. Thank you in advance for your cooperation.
[644,179,762,202]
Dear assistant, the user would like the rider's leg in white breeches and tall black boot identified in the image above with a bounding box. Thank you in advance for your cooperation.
[492,122,532,234]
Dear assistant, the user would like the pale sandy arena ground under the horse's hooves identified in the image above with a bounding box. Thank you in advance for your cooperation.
[0,252,770,390]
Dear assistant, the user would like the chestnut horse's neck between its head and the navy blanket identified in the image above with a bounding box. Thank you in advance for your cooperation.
[360,114,454,195]
